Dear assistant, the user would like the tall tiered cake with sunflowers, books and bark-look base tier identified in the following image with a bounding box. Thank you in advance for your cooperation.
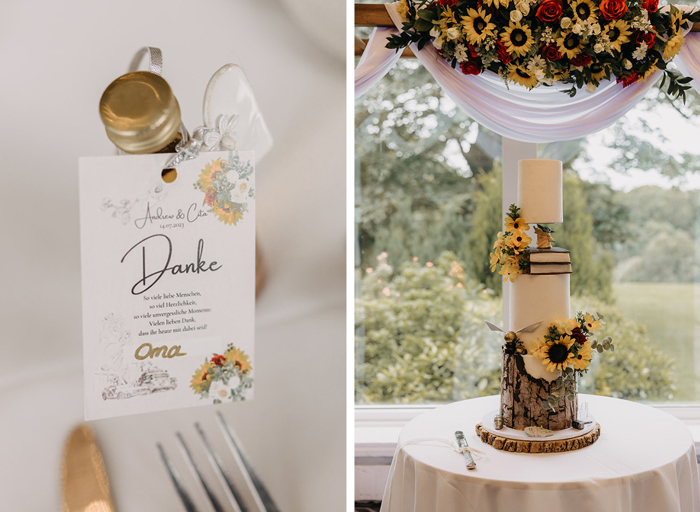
[487,160,614,452]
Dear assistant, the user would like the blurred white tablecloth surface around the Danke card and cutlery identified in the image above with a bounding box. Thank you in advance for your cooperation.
[0,0,345,512]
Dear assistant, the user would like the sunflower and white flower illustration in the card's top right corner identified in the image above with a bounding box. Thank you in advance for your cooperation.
[194,153,255,226]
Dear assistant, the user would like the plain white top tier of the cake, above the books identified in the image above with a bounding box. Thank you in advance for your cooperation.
[517,159,564,224]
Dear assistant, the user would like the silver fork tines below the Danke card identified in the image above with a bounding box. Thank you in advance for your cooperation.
[157,412,279,512]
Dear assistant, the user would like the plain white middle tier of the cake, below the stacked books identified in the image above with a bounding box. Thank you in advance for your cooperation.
[509,274,571,353]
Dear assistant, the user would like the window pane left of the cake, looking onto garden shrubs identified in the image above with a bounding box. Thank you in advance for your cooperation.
[355,59,501,403]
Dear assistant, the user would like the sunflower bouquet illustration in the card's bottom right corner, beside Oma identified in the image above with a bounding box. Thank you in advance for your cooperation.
[190,344,253,404]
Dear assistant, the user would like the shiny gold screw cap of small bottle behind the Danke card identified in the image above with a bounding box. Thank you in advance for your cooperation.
[100,71,180,154]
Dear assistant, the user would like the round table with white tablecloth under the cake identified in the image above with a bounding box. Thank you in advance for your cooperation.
[381,395,700,512]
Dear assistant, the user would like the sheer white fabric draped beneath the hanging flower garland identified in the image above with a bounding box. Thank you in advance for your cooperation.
[355,3,700,142]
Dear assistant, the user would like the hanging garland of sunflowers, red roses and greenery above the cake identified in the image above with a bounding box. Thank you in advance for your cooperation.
[387,0,700,101]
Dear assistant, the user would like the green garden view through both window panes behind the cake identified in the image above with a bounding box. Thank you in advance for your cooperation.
[356,59,700,403]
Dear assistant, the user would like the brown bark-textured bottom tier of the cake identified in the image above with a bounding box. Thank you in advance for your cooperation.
[501,351,578,430]
